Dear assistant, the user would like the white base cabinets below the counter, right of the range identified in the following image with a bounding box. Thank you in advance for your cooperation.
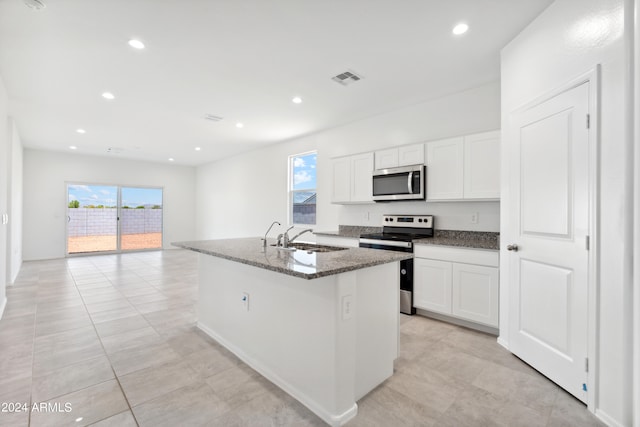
[413,245,499,328]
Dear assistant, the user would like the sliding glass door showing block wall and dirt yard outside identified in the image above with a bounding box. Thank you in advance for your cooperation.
[67,184,162,255]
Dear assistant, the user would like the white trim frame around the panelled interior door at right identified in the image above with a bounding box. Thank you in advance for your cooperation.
[498,64,601,413]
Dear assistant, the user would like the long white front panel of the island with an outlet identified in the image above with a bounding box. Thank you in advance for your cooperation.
[198,254,357,425]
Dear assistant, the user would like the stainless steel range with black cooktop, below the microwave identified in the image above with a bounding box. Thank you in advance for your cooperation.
[360,215,433,314]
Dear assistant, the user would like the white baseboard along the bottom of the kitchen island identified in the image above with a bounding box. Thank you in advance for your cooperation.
[196,322,358,427]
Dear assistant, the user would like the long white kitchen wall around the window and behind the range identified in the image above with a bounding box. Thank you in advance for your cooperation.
[196,83,500,239]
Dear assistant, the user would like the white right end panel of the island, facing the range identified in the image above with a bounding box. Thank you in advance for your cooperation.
[355,262,400,400]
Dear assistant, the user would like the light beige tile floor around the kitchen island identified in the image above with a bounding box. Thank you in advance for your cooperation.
[0,250,600,427]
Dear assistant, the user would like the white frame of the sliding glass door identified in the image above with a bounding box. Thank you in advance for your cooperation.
[63,181,164,258]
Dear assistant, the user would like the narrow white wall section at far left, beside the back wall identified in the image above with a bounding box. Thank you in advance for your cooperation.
[8,121,23,283]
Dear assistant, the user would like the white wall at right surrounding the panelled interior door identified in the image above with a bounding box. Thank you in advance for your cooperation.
[500,0,633,425]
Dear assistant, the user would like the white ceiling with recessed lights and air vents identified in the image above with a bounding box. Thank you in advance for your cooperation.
[0,0,552,165]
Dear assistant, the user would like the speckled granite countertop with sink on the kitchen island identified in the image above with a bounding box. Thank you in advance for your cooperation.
[171,237,413,279]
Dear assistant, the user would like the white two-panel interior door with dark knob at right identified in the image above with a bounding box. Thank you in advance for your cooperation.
[505,83,589,401]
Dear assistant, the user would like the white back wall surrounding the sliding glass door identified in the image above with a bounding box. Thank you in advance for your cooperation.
[23,149,196,260]
